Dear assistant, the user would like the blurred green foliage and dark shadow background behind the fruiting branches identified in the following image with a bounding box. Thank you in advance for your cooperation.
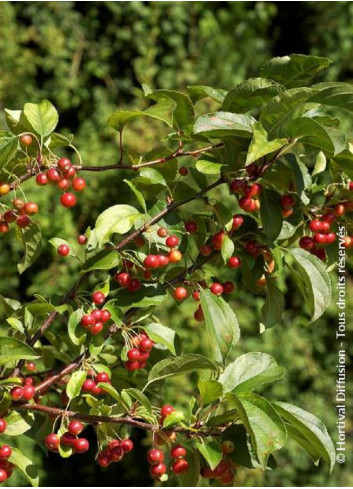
[0,1,353,487]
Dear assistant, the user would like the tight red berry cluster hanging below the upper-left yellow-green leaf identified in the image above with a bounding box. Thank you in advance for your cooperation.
[36,158,86,207]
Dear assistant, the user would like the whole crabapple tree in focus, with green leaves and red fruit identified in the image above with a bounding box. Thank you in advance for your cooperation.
[0,55,353,486]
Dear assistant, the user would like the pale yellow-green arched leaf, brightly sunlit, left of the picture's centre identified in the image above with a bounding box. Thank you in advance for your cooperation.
[94,204,141,246]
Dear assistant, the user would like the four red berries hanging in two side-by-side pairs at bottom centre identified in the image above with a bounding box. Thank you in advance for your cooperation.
[147,445,189,479]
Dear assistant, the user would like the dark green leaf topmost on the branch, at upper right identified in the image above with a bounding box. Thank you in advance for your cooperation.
[261,54,332,88]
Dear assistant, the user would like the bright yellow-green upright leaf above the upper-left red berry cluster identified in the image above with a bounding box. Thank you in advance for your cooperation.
[23,100,59,138]
